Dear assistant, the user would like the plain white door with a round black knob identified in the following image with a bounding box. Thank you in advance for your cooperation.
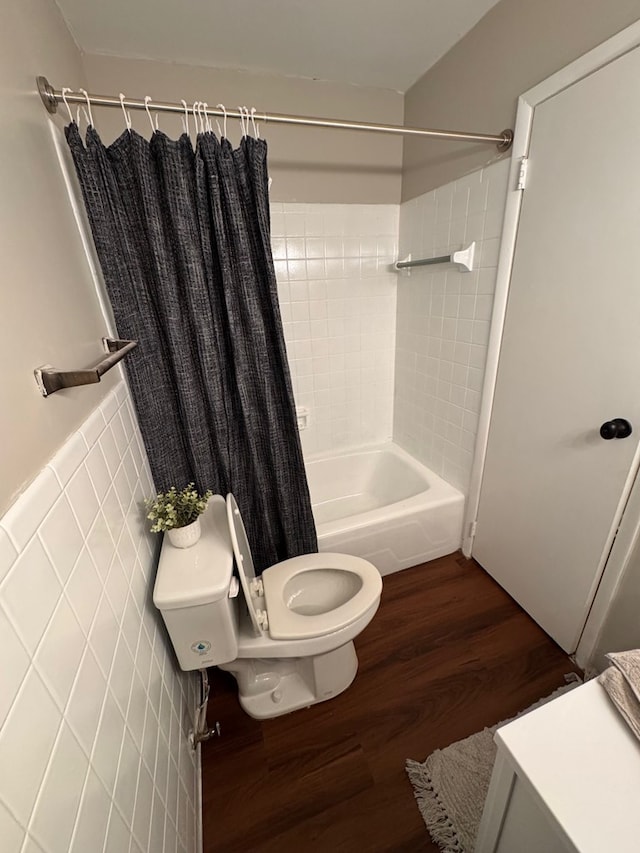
[473,41,640,652]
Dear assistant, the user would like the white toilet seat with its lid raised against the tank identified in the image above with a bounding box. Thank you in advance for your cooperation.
[226,493,382,640]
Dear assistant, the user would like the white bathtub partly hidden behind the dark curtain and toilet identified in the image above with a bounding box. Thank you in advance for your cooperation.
[305,443,464,575]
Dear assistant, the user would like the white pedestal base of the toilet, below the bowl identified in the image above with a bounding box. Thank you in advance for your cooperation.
[219,642,358,720]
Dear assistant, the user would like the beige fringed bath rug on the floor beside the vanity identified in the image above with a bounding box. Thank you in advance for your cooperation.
[407,673,582,853]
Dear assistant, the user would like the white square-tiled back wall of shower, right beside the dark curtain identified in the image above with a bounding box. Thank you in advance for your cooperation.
[271,203,399,455]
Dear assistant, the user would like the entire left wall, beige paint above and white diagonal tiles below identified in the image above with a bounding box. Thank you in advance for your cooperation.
[0,0,196,853]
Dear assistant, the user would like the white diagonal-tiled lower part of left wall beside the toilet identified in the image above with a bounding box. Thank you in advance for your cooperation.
[0,383,197,853]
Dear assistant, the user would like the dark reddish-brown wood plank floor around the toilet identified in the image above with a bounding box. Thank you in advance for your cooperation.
[202,554,575,853]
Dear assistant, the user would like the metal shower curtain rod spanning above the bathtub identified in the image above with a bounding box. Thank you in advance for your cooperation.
[36,77,513,151]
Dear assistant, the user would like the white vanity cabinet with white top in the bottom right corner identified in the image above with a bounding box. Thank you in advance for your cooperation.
[475,681,640,853]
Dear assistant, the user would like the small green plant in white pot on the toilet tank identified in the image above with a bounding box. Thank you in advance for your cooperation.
[146,483,213,548]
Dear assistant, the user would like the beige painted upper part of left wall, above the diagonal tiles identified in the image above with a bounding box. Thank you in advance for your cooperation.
[0,0,114,513]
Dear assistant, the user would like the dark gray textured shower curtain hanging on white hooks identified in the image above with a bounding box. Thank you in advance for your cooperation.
[66,124,317,571]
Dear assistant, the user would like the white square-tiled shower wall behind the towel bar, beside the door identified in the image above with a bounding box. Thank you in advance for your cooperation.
[393,160,509,492]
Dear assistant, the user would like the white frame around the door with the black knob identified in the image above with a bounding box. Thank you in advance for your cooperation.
[462,21,640,665]
